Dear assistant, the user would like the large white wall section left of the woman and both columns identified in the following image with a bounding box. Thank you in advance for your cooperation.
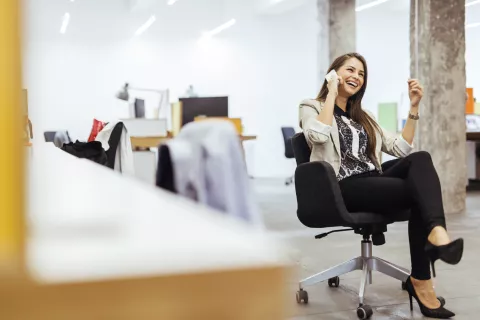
[24,0,317,177]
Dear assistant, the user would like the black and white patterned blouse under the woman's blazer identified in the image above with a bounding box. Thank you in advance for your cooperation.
[334,106,376,181]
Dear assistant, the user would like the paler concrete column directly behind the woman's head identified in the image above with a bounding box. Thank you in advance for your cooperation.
[317,0,357,84]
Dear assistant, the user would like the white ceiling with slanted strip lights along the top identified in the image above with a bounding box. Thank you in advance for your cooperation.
[24,0,480,42]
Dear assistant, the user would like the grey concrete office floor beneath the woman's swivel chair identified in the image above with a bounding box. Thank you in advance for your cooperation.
[254,179,480,320]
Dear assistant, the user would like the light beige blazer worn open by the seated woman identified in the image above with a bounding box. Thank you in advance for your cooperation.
[300,99,413,175]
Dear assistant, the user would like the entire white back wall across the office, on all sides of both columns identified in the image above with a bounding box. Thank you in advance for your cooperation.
[24,0,480,177]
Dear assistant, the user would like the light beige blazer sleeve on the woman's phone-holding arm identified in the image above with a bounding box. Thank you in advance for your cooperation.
[300,104,332,144]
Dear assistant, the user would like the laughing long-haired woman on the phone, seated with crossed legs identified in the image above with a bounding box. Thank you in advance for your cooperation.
[300,53,463,319]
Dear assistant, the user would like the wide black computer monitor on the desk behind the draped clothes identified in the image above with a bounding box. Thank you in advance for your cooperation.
[180,97,228,126]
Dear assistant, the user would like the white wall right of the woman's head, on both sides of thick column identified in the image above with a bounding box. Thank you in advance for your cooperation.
[357,0,480,118]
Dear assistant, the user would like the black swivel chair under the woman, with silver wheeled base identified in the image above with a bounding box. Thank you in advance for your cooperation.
[292,133,410,319]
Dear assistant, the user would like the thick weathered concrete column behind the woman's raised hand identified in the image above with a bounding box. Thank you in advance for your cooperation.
[410,0,467,214]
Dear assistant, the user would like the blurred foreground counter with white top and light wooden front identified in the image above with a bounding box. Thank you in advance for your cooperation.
[0,145,288,320]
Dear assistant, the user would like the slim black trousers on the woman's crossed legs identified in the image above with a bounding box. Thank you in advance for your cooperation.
[339,151,446,280]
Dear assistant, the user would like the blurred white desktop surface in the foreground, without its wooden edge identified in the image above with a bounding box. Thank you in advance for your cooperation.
[27,144,285,283]
